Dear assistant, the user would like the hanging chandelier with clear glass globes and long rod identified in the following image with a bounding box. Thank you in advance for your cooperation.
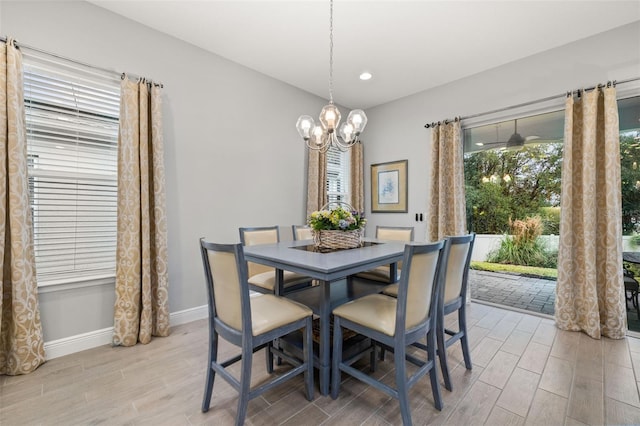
[296,0,367,152]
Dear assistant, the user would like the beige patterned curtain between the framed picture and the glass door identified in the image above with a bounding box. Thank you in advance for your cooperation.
[427,119,467,241]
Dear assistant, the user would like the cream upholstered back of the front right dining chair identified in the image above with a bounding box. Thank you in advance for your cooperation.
[396,241,448,333]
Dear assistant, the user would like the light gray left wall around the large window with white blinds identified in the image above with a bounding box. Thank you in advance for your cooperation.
[0,1,325,341]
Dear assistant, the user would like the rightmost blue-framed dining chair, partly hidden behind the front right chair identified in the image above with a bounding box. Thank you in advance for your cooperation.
[436,233,476,391]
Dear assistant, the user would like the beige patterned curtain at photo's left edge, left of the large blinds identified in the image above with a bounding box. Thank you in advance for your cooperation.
[0,39,45,374]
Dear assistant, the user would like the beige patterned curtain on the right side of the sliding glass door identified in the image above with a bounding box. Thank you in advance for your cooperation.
[555,87,627,339]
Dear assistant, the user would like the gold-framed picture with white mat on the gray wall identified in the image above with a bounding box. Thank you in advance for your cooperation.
[371,160,409,213]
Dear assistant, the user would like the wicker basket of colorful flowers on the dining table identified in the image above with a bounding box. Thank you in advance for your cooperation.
[308,202,367,250]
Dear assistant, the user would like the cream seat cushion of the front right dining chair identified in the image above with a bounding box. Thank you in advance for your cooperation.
[333,294,398,336]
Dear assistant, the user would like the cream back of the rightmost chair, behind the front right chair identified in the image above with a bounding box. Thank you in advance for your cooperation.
[443,233,476,305]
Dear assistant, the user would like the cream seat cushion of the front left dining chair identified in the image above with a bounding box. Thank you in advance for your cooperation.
[251,294,313,336]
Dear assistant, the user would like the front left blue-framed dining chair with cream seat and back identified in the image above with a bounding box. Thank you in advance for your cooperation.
[200,238,314,425]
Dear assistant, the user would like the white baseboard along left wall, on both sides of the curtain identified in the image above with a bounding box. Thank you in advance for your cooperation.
[44,305,209,360]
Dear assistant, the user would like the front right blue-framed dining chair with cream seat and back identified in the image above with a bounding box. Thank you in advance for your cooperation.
[331,241,448,425]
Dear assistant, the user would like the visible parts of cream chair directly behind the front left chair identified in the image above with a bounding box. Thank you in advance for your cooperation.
[240,226,311,294]
